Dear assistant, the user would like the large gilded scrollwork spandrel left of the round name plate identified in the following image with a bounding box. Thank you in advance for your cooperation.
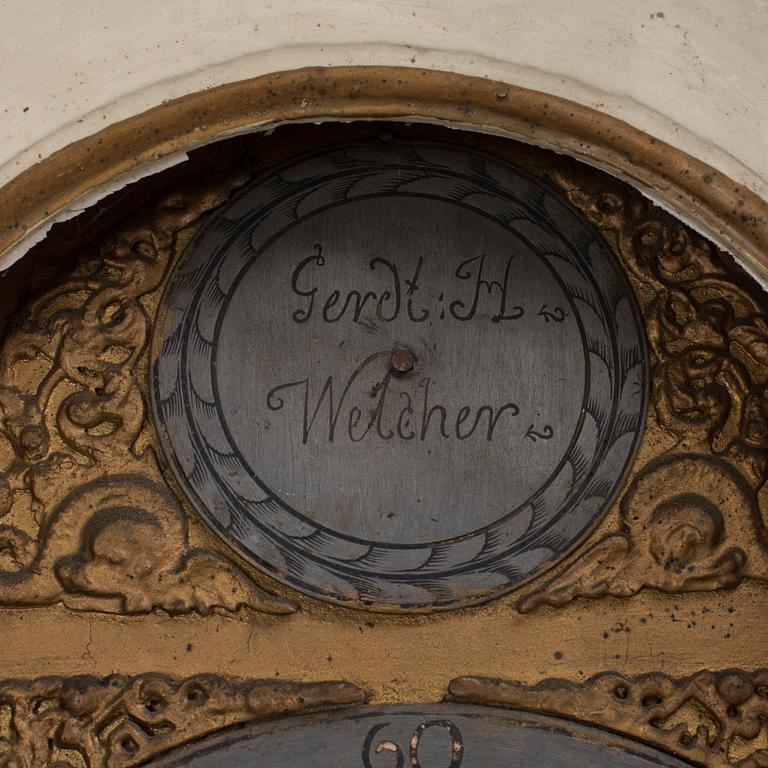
[0,178,293,614]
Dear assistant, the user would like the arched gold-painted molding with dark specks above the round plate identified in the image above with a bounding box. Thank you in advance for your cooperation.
[0,66,768,284]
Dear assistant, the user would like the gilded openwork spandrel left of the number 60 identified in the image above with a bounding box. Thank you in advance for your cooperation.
[0,674,365,768]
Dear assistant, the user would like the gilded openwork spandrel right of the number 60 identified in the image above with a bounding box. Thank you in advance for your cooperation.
[449,669,768,768]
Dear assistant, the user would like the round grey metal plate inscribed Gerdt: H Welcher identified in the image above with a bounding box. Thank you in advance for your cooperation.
[152,144,647,609]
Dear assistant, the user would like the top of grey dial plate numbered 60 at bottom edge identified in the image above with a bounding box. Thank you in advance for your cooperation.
[152,704,690,768]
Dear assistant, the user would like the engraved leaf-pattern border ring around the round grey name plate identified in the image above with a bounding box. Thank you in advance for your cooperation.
[151,143,649,610]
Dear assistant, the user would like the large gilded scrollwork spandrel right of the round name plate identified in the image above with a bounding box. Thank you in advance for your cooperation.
[519,175,768,612]
